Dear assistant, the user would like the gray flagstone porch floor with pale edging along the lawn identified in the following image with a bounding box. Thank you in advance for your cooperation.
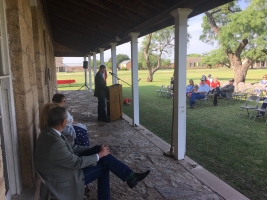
[12,90,248,200]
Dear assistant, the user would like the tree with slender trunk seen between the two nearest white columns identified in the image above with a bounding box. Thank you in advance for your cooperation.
[138,27,174,82]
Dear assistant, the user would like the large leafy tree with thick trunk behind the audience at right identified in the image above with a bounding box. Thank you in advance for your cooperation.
[200,0,267,84]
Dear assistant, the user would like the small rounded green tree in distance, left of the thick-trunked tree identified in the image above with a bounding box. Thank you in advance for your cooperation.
[202,49,231,68]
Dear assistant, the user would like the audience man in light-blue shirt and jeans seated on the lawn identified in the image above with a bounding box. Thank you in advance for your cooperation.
[189,76,210,108]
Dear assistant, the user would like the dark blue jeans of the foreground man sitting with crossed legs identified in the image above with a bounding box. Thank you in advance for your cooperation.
[79,146,133,200]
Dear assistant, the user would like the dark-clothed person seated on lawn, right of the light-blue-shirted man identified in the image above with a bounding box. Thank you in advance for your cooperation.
[213,79,235,106]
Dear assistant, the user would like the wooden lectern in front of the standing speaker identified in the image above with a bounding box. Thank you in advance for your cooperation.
[106,84,122,121]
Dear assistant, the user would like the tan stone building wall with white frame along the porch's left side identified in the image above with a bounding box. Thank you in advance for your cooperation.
[0,0,56,199]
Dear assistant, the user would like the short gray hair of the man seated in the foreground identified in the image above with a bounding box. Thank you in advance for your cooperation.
[47,107,68,127]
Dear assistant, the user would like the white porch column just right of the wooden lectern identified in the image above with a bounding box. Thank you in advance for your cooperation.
[129,32,140,126]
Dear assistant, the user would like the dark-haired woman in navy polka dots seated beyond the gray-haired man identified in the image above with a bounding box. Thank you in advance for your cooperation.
[52,94,89,147]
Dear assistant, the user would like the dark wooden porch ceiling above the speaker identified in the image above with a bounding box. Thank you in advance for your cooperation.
[41,0,232,57]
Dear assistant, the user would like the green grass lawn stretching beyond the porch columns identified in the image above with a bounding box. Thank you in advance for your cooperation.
[57,69,267,199]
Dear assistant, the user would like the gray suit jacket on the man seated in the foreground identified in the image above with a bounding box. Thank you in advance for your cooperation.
[35,127,97,200]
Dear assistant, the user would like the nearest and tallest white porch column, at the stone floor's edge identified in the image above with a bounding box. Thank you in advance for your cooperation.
[171,8,192,160]
